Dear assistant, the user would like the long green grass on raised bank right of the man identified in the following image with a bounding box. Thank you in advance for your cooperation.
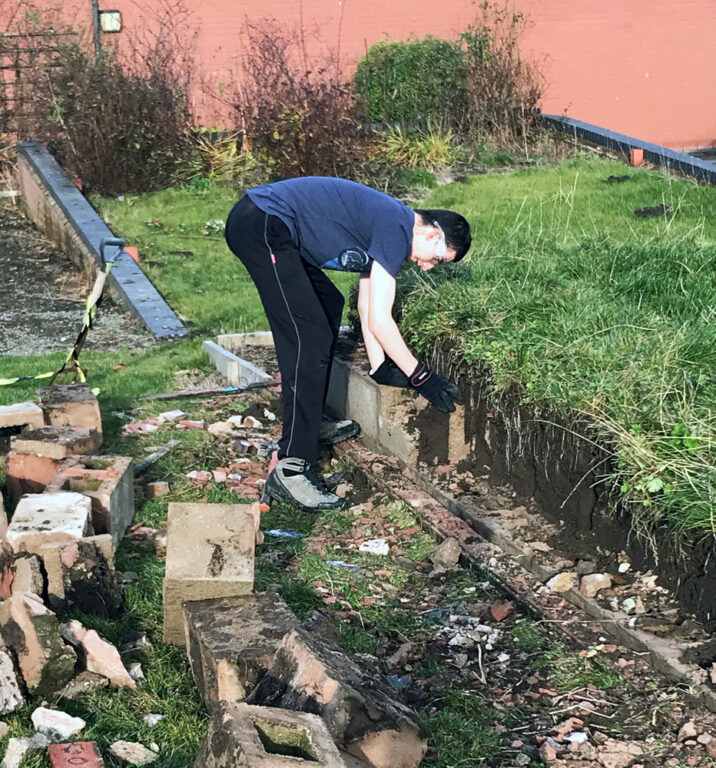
[401,158,716,533]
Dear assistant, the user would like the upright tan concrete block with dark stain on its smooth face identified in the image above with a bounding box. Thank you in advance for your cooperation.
[164,503,261,644]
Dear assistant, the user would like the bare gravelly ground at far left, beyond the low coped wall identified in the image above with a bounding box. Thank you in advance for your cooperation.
[0,206,155,355]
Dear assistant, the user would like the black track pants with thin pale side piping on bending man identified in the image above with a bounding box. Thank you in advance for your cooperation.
[226,195,343,461]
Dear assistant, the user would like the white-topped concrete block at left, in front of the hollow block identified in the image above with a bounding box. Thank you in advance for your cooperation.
[7,492,93,554]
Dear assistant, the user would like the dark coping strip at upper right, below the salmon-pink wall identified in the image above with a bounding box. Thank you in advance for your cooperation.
[542,115,716,184]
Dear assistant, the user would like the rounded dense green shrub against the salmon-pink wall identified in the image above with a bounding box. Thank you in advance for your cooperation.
[354,36,466,123]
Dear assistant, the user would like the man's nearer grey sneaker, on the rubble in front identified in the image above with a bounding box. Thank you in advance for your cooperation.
[261,456,346,512]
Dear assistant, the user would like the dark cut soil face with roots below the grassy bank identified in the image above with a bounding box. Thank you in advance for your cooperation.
[426,348,716,632]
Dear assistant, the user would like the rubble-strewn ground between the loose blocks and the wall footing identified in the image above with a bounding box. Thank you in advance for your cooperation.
[117,384,716,768]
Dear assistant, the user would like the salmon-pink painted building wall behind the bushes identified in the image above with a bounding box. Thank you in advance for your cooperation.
[4,0,716,149]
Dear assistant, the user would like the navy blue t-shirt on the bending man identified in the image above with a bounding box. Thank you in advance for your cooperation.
[246,176,415,277]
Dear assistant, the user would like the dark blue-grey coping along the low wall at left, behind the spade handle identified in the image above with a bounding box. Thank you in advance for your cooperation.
[16,141,187,339]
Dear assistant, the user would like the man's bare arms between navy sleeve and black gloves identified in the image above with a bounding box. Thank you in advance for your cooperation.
[366,261,418,376]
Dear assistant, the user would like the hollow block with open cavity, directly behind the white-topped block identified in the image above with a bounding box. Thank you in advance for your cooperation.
[46,456,134,546]
